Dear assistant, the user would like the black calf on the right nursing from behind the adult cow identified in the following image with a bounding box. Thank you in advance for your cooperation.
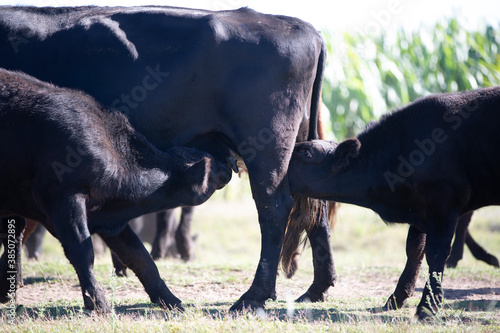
[289,87,500,318]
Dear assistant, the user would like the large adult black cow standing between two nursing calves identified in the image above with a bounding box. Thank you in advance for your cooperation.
[0,7,336,310]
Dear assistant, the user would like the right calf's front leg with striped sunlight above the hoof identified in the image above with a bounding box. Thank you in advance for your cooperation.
[416,214,457,320]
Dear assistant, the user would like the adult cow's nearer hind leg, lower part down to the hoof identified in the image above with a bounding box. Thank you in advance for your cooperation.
[230,183,292,311]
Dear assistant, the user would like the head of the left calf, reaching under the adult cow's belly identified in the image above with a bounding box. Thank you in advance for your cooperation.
[167,147,231,206]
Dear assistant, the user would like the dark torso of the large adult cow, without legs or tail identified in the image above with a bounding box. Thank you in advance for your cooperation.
[0,7,322,148]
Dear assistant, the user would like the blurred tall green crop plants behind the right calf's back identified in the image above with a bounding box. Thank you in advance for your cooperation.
[323,18,500,140]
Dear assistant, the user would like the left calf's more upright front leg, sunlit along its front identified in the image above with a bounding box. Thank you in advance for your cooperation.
[45,194,110,313]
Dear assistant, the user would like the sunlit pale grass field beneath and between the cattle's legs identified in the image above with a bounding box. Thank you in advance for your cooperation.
[0,178,500,332]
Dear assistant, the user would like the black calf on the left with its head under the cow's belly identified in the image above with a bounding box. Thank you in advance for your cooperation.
[0,69,230,312]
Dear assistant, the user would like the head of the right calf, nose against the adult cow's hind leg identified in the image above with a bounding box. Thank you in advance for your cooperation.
[288,138,361,200]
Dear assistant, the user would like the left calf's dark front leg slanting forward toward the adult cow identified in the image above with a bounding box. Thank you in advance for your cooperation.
[100,224,182,309]
